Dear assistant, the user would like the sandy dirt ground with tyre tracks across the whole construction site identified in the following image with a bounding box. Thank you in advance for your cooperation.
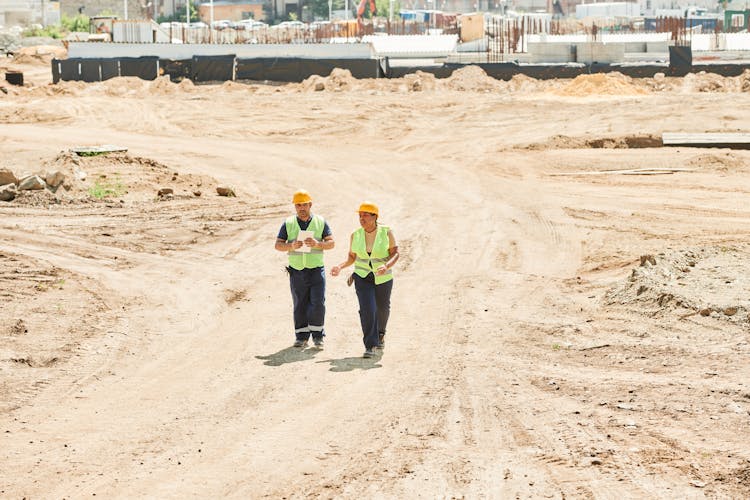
[0,51,750,499]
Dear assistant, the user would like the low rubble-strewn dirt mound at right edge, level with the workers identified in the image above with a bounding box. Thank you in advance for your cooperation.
[604,245,750,324]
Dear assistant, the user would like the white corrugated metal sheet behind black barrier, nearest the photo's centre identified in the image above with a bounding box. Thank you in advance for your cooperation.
[362,35,458,59]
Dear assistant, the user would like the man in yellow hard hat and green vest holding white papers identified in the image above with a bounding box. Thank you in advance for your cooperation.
[276,189,334,349]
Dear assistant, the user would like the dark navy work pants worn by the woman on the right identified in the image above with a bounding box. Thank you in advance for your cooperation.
[354,273,393,349]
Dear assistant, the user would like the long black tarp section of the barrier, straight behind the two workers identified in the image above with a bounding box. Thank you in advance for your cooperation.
[236,57,383,82]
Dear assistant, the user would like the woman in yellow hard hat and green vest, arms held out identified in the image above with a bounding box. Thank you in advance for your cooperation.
[331,202,399,358]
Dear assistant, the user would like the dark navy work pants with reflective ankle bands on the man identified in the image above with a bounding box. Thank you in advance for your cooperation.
[287,267,326,340]
